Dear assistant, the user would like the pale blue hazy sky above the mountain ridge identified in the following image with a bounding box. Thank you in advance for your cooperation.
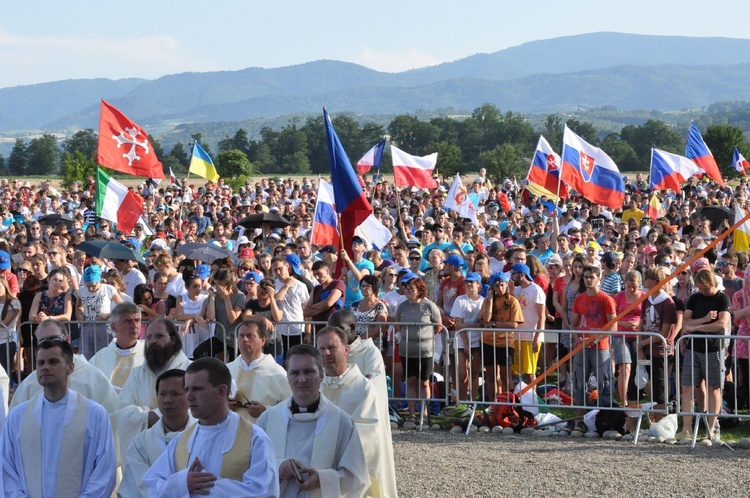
[0,0,750,88]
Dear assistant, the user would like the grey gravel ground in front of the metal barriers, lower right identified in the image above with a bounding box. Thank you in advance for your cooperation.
[393,430,750,498]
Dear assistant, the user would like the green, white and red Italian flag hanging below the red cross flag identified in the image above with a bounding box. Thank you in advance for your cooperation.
[96,168,143,234]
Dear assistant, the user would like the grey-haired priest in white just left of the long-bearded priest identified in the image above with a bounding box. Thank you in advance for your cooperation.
[89,301,144,391]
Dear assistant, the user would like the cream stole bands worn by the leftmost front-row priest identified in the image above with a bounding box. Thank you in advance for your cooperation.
[21,392,88,498]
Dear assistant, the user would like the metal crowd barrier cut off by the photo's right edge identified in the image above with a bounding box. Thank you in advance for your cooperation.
[675,333,750,447]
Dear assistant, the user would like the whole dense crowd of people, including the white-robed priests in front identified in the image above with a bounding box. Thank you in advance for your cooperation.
[0,171,750,496]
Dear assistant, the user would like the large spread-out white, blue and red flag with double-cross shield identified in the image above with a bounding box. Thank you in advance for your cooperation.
[562,126,625,209]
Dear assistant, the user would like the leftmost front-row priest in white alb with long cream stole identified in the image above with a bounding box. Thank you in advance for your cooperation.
[0,338,116,498]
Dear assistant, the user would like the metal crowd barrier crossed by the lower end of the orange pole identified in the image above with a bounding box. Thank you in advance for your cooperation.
[452,327,671,443]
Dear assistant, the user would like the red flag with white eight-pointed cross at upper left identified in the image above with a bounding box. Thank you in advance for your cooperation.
[97,100,164,180]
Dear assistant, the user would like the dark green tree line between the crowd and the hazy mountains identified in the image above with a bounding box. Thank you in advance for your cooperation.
[0,104,750,185]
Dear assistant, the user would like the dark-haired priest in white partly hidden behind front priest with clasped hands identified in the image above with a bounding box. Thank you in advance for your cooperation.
[118,369,196,498]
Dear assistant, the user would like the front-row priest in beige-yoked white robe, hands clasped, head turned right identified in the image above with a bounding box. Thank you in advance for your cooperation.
[143,358,279,498]
